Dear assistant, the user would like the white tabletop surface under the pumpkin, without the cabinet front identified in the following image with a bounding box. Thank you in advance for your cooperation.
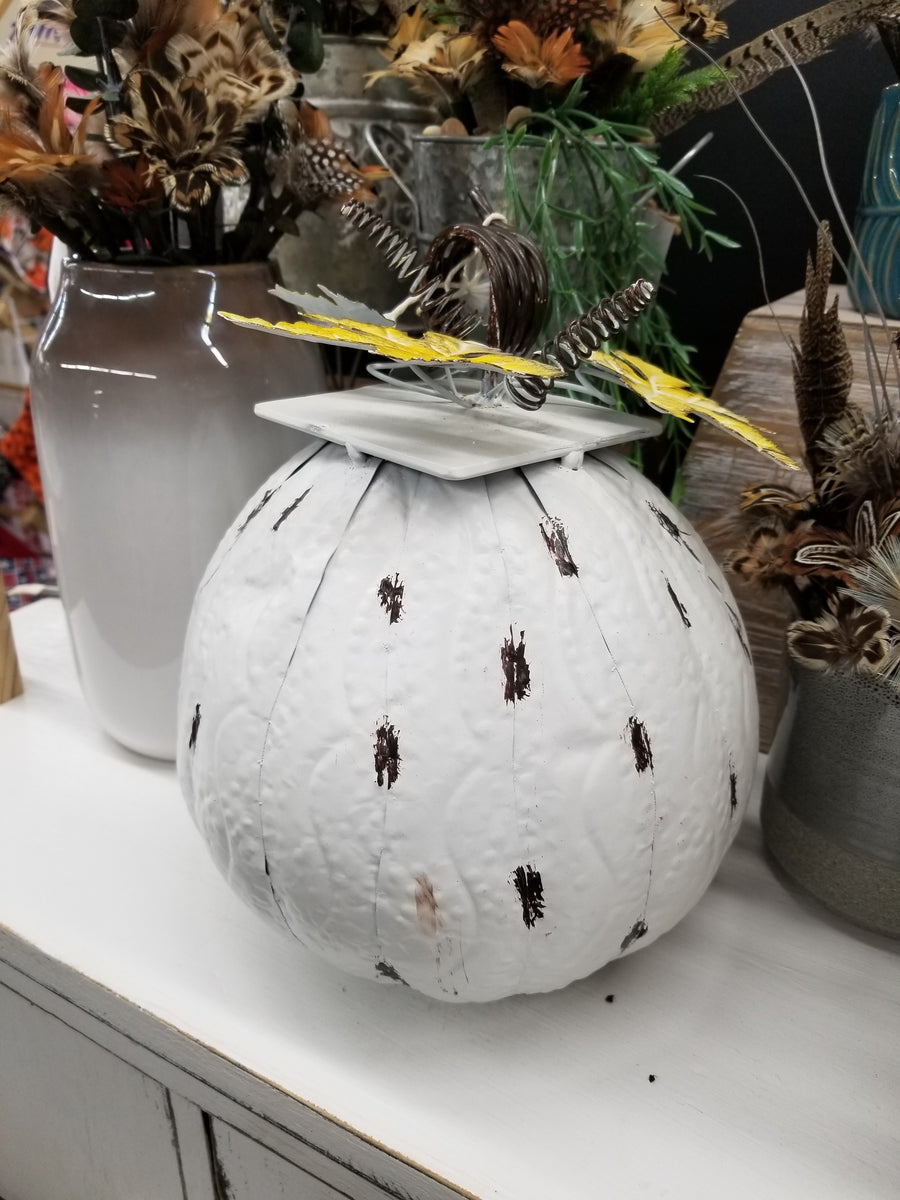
[0,600,900,1200]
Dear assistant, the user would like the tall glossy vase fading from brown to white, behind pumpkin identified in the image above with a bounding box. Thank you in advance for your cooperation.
[31,262,324,758]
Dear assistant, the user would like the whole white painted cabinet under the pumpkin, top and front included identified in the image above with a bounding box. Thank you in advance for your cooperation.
[0,600,900,1200]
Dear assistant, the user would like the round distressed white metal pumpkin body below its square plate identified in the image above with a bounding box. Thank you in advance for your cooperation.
[179,398,757,1001]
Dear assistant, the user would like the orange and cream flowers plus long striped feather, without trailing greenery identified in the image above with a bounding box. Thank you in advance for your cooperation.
[377,0,895,136]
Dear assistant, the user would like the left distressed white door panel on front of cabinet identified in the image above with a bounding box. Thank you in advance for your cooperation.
[0,985,185,1200]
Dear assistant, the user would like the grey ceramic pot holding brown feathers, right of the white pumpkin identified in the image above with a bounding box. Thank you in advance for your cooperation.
[762,664,900,937]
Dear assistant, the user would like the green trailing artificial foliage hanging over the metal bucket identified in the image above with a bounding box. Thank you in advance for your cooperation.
[501,84,734,499]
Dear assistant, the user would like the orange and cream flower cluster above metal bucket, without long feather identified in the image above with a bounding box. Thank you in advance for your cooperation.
[369,0,726,133]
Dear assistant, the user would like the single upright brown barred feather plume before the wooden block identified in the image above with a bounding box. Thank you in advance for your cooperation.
[791,222,853,485]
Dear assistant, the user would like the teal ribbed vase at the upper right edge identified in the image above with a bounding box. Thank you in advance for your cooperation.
[850,84,900,317]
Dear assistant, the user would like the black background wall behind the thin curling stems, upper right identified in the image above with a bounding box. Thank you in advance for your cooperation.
[660,0,896,386]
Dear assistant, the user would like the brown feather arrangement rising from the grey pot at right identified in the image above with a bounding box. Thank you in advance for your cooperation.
[725,226,900,689]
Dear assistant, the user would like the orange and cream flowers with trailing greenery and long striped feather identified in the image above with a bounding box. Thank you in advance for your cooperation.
[369,0,896,499]
